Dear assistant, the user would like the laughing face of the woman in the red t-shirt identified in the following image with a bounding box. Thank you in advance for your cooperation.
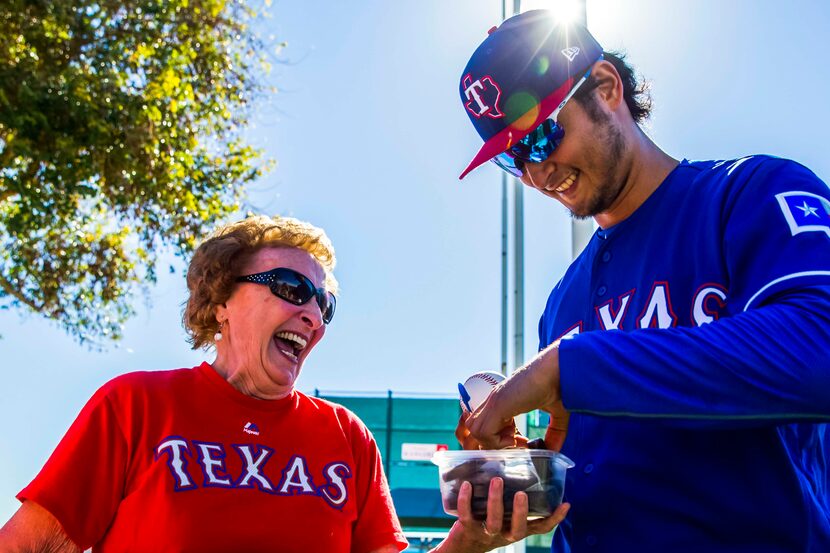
[215,247,326,399]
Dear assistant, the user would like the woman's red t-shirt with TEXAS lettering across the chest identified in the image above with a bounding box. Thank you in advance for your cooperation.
[17,363,407,553]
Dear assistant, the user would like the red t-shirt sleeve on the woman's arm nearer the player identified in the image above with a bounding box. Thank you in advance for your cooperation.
[352,417,409,553]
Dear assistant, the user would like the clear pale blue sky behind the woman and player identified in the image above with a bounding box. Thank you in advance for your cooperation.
[0,0,830,523]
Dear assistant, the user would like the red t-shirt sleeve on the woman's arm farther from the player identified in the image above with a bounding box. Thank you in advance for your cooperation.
[17,384,128,549]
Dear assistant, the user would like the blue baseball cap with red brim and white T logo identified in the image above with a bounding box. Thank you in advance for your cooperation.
[458,10,602,179]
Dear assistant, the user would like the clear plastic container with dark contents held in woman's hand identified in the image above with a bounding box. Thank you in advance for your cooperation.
[432,449,574,520]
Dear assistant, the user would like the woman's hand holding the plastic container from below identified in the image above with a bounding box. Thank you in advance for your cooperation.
[434,478,570,553]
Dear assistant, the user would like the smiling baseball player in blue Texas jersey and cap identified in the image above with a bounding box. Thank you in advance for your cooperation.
[460,11,830,553]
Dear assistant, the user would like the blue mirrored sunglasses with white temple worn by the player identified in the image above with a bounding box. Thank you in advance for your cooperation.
[490,63,602,178]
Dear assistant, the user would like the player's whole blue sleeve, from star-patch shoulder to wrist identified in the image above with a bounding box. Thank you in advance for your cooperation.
[559,159,830,427]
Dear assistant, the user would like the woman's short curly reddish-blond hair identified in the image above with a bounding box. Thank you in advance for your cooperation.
[182,215,338,349]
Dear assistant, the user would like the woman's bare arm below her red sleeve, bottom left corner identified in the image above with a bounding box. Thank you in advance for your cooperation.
[0,501,81,553]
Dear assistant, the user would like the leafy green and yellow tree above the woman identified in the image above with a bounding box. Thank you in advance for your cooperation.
[0,0,276,346]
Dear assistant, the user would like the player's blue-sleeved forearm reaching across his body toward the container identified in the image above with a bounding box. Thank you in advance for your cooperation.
[559,287,830,425]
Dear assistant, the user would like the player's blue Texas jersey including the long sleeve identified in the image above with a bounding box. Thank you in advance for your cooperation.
[539,156,830,553]
